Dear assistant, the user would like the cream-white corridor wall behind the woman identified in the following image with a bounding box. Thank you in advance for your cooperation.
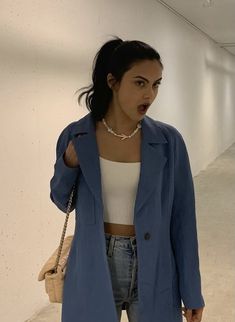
[0,0,235,322]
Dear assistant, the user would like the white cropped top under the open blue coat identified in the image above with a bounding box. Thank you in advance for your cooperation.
[99,157,140,225]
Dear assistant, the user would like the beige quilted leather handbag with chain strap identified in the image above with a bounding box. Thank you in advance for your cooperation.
[38,186,75,303]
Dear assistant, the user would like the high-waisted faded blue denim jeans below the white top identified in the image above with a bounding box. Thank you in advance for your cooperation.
[105,233,138,322]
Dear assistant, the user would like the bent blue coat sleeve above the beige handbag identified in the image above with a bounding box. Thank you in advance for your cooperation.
[50,123,81,213]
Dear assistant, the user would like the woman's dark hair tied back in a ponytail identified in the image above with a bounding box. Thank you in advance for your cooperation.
[76,36,163,123]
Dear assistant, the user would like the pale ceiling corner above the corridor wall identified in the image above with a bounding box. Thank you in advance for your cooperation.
[156,0,235,56]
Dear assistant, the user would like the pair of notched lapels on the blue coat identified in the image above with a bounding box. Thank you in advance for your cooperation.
[71,113,167,216]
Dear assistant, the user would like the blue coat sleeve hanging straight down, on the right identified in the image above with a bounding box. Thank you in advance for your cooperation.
[171,129,205,309]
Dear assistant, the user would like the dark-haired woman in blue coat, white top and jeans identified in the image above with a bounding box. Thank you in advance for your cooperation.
[50,37,205,322]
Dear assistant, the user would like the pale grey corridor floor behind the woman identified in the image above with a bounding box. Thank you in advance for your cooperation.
[28,144,235,322]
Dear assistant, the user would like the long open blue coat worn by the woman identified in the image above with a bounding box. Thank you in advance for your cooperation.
[50,112,205,322]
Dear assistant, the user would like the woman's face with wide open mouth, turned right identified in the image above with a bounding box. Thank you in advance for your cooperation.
[107,60,162,121]
